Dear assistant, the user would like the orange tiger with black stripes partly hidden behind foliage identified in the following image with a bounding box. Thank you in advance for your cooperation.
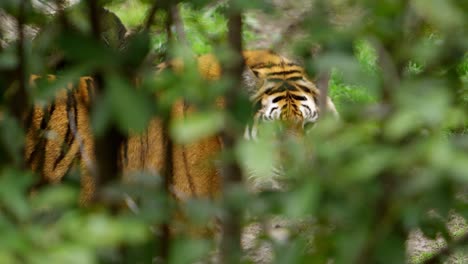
[24,50,338,204]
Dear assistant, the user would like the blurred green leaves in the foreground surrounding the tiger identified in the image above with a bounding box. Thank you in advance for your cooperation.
[0,0,468,263]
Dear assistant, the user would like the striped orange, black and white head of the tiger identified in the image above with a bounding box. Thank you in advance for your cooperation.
[244,51,337,138]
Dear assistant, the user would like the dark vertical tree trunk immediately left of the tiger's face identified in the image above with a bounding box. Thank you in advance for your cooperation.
[221,7,245,263]
